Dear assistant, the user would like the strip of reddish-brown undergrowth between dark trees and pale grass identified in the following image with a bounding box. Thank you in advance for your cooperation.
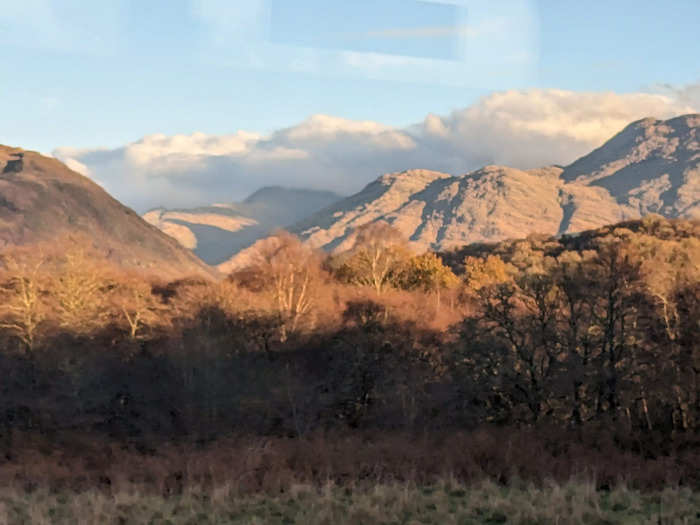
[0,428,700,495]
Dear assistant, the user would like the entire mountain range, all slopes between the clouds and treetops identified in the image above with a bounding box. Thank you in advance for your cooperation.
[0,114,700,277]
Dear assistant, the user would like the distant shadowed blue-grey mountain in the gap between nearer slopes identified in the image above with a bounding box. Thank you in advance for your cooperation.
[143,186,342,264]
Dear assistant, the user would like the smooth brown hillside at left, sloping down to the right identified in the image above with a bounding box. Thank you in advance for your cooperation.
[0,145,217,278]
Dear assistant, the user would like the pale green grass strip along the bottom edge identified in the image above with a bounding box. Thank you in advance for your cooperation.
[0,481,700,525]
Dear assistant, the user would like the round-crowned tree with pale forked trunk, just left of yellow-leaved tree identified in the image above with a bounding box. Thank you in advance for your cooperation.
[336,222,410,295]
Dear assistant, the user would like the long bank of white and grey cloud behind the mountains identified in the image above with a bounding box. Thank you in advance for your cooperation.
[53,86,698,211]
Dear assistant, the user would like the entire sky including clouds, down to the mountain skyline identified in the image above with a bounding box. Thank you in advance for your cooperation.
[0,0,700,211]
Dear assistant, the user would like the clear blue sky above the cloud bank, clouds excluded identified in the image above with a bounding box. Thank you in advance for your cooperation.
[0,0,700,152]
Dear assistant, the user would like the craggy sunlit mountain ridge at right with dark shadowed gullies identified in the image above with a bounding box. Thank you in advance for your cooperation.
[291,115,700,250]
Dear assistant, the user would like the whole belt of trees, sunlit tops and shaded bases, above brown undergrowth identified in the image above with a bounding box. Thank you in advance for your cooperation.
[0,217,700,453]
